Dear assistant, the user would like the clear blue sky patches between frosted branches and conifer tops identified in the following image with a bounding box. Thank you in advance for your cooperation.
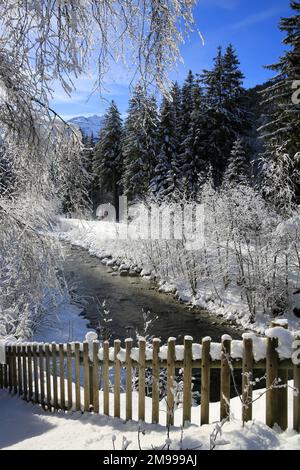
[51,0,291,119]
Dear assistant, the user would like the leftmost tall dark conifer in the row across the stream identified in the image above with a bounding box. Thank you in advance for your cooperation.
[93,101,123,216]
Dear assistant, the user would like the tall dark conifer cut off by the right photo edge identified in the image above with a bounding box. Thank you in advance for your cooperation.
[260,1,300,205]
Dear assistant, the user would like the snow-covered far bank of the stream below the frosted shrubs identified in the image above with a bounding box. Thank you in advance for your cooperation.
[57,218,299,333]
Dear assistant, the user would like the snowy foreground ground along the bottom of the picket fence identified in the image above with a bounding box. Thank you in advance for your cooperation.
[0,391,300,450]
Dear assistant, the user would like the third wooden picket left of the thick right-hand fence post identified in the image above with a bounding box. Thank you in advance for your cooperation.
[201,337,211,425]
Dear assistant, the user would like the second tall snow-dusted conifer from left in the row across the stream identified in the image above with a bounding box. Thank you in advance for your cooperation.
[122,85,158,200]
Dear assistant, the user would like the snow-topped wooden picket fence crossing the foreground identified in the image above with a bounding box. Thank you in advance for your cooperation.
[0,324,300,432]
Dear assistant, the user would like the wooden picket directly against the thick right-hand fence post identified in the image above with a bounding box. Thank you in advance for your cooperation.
[266,338,278,428]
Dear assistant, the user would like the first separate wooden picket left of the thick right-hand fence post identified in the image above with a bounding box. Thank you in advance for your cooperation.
[242,337,253,423]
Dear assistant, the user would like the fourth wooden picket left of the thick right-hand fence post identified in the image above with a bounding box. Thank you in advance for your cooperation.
[182,336,193,425]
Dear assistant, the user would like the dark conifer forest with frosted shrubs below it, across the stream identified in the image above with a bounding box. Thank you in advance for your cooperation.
[57,2,300,328]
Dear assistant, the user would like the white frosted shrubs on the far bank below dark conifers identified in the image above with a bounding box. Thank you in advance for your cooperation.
[77,181,300,324]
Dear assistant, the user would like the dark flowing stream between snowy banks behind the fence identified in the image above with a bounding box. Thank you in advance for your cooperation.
[64,245,240,343]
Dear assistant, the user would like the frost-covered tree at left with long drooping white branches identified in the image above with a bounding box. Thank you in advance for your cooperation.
[0,0,195,336]
